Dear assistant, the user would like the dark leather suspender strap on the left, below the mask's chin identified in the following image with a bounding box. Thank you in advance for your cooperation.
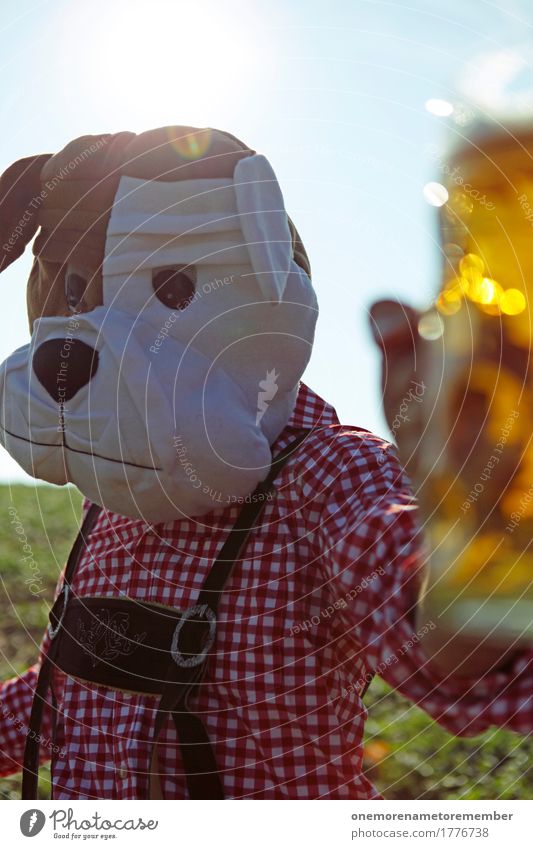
[22,504,102,799]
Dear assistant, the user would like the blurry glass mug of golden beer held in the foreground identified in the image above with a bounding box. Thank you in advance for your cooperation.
[416,122,533,647]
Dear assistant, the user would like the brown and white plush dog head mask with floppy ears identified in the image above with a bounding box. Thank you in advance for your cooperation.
[0,127,317,522]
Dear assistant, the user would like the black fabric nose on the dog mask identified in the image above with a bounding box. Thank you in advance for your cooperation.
[32,338,98,403]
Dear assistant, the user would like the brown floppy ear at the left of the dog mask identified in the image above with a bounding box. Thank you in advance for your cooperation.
[0,153,52,272]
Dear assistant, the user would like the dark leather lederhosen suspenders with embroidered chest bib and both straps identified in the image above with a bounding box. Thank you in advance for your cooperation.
[22,429,310,799]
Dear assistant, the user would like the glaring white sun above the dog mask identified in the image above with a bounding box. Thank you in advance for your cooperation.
[56,0,257,130]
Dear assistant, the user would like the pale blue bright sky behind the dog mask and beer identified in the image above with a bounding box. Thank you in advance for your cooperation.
[0,0,533,480]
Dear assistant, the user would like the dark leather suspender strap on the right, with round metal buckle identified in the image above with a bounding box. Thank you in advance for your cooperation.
[148,429,310,799]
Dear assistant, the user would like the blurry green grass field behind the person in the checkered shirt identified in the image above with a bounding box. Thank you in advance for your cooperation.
[0,485,533,799]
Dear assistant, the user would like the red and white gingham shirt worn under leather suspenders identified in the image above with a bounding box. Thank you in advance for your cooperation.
[0,385,533,799]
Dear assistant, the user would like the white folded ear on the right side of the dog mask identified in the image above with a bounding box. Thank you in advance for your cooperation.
[233,154,293,304]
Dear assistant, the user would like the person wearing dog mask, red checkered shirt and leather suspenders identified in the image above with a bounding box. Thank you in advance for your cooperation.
[0,127,533,799]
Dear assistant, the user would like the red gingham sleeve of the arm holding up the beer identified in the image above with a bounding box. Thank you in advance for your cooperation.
[319,434,533,736]
